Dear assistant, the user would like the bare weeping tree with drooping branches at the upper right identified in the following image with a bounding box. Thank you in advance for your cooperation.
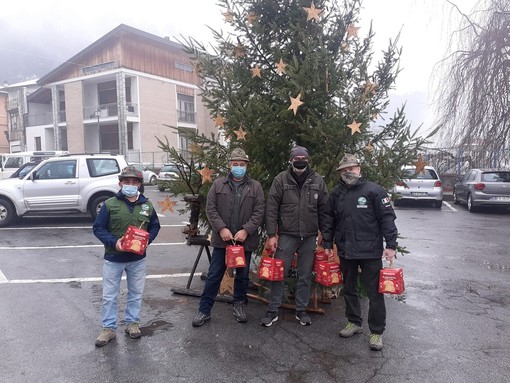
[436,0,510,166]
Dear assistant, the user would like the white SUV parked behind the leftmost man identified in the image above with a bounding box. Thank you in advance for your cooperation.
[0,154,127,227]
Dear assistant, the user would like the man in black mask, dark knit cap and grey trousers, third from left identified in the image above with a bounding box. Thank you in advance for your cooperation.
[260,146,328,327]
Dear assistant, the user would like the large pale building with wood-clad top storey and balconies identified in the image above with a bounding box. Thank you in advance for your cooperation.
[11,24,215,166]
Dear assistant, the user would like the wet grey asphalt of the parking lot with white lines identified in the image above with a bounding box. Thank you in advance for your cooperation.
[0,191,510,383]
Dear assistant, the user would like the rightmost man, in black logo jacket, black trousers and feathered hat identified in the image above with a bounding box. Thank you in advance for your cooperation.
[323,154,398,351]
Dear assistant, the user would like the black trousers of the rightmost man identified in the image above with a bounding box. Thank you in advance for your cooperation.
[341,258,386,334]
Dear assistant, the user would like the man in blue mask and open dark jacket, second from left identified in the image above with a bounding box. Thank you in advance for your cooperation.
[192,149,265,327]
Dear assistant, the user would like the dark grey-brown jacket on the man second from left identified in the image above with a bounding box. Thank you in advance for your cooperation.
[205,176,265,251]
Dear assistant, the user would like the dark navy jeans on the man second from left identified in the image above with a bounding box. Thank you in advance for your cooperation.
[199,247,251,315]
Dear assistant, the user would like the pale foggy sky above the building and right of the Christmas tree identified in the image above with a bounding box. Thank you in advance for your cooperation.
[0,0,477,135]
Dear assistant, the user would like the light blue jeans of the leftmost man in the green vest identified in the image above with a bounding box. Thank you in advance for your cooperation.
[102,258,147,330]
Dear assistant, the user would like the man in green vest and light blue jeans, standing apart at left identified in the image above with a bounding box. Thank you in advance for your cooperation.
[93,166,160,347]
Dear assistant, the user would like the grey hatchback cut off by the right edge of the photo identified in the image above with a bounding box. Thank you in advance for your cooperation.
[453,169,510,212]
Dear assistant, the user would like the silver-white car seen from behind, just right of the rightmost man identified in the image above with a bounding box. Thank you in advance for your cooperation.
[393,166,443,209]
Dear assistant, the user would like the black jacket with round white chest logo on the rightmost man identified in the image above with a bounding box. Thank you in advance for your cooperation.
[322,177,398,259]
